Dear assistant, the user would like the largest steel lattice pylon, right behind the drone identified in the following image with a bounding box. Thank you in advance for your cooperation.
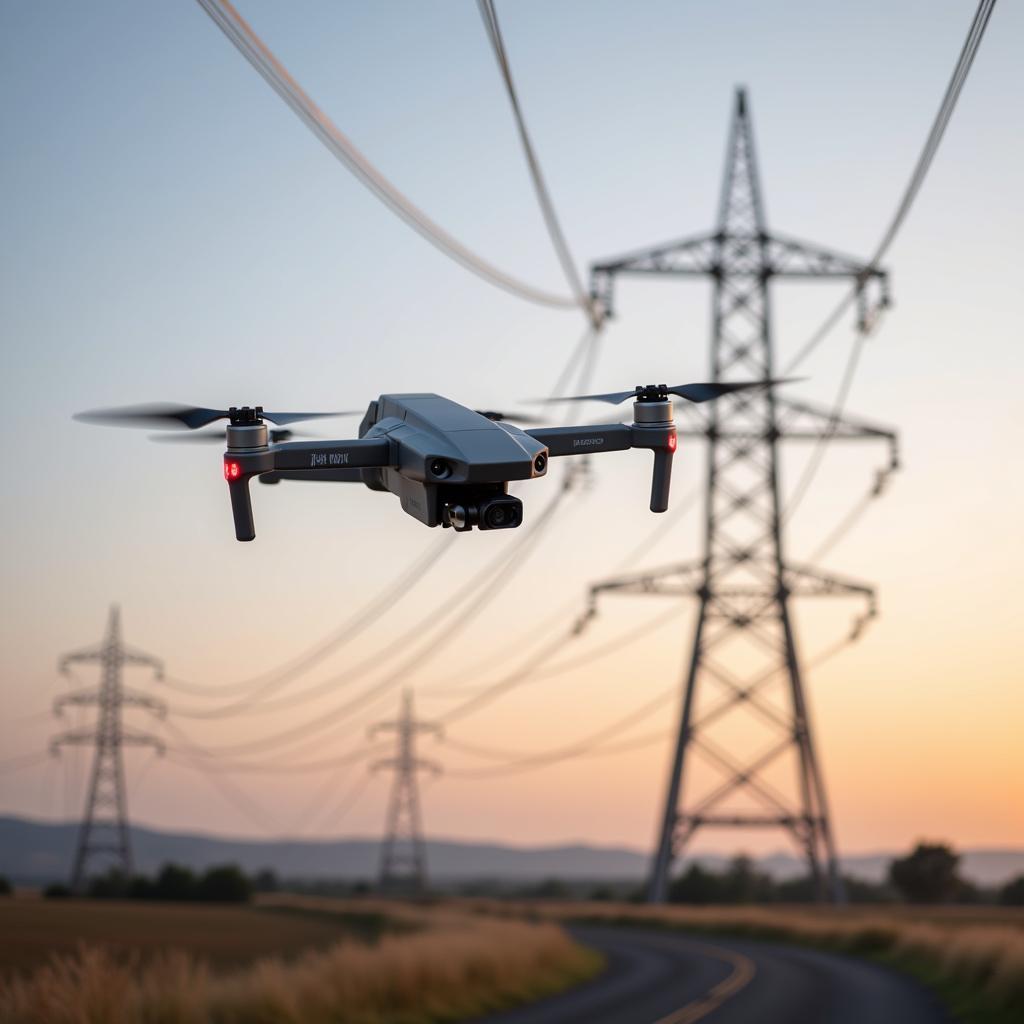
[591,89,897,902]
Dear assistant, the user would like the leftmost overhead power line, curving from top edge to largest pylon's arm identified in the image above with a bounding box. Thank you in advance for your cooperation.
[198,0,578,308]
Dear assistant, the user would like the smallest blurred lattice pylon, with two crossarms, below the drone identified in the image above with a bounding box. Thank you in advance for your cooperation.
[370,690,441,894]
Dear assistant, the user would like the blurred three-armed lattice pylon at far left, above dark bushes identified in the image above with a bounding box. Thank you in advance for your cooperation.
[50,605,167,892]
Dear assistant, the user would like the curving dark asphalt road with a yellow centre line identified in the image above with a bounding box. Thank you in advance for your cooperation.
[473,927,951,1024]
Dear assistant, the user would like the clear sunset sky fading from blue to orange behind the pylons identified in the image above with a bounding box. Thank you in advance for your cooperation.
[0,0,1024,853]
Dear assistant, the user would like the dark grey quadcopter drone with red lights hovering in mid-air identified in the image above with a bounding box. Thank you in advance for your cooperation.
[75,380,784,541]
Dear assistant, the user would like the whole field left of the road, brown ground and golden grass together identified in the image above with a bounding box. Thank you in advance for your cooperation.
[0,897,601,1024]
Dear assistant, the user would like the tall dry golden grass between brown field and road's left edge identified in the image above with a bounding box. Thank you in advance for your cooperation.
[0,900,600,1024]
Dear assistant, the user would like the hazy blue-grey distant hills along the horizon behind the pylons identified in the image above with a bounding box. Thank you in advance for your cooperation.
[0,817,1024,885]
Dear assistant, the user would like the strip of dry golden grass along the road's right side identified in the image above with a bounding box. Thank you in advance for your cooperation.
[476,901,1024,1020]
